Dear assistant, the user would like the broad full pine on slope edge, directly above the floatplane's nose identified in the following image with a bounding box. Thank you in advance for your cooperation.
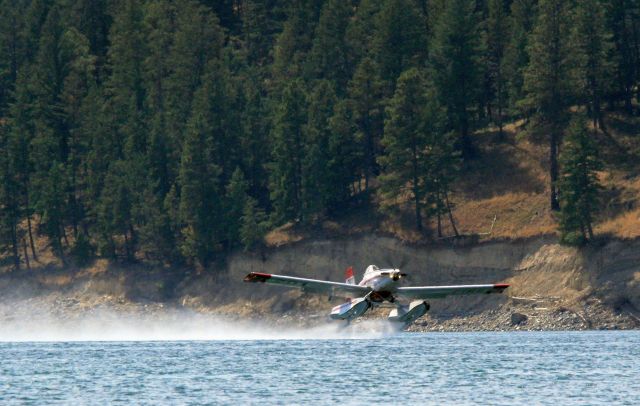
[379,68,436,232]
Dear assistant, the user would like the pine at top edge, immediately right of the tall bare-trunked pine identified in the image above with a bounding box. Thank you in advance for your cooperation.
[572,0,613,130]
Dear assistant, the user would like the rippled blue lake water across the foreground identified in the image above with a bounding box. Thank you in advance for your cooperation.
[0,331,640,405]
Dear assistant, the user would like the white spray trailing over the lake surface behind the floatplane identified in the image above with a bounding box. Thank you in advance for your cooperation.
[0,308,399,342]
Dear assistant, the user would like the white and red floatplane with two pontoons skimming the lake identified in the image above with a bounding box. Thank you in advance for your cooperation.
[244,265,509,325]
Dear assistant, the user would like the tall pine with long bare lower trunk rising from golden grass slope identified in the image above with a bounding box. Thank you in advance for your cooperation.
[520,0,573,210]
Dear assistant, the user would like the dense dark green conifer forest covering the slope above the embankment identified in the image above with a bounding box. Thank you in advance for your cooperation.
[0,0,640,268]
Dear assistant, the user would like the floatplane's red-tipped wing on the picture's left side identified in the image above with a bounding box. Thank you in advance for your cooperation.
[244,272,371,297]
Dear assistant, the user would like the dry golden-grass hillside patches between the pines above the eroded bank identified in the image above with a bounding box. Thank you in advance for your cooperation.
[266,113,640,246]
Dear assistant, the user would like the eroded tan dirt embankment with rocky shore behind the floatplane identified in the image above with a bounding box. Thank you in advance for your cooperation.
[0,236,640,331]
